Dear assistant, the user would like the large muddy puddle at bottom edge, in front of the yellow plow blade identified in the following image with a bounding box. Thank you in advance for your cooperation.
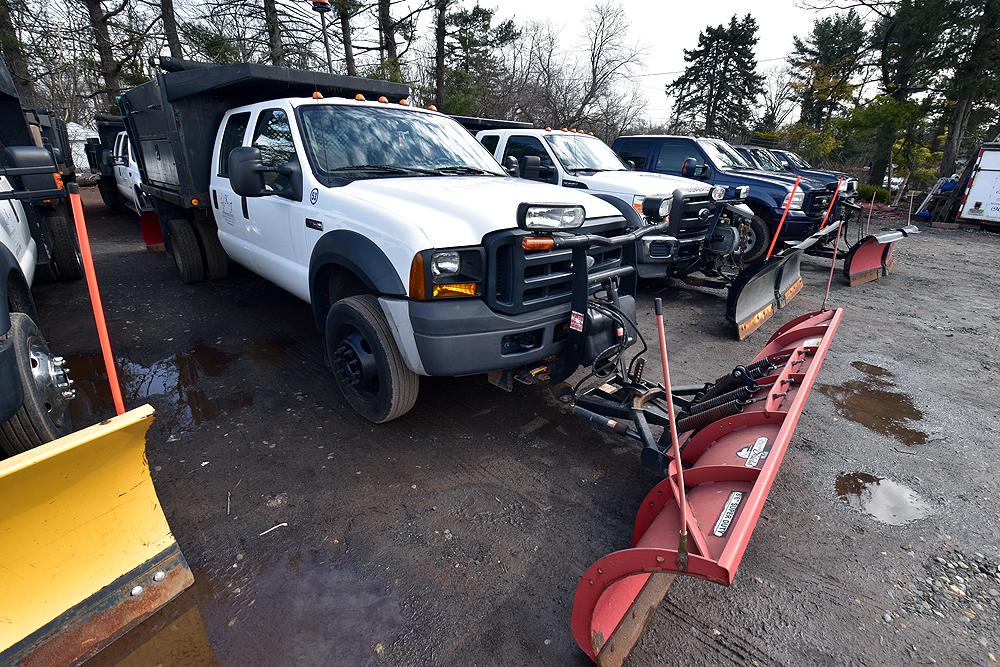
[94,550,403,667]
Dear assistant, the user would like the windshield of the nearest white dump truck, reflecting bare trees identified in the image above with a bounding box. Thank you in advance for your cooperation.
[299,104,507,180]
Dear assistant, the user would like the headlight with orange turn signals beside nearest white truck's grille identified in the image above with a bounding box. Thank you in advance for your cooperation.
[409,248,486,301]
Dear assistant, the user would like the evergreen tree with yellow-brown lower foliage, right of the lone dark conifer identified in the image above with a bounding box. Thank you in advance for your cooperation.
[788,9,867,130]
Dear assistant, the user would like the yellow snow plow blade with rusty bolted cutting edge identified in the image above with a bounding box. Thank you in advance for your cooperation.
[0,405,194,665]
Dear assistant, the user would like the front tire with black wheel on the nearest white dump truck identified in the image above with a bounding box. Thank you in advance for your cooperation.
[326,294,420,424]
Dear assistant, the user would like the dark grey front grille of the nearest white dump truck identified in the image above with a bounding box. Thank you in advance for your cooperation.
[484,218,625,315]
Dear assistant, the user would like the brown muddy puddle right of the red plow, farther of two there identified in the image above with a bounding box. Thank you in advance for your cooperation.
[819,361,927,446]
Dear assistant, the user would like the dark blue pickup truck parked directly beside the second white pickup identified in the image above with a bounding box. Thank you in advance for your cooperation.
[612,135,831,262]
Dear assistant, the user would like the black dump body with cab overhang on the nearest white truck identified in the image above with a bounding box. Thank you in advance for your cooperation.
[118,57,410,208]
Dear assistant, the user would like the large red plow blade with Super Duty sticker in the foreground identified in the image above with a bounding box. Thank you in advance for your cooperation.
[571,309,844,665]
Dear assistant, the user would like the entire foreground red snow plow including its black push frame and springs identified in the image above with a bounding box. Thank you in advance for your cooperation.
[516,202,844,665]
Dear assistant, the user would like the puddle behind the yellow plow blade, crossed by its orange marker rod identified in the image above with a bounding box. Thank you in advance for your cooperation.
[66,343,253,428]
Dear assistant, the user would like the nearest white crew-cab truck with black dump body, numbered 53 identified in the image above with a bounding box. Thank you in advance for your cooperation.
[120,58,635,423]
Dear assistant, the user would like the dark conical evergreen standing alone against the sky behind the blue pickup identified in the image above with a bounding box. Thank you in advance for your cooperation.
[667,14,764,136]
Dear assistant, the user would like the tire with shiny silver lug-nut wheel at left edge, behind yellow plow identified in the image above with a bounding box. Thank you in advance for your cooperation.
[0,313,73,456]
